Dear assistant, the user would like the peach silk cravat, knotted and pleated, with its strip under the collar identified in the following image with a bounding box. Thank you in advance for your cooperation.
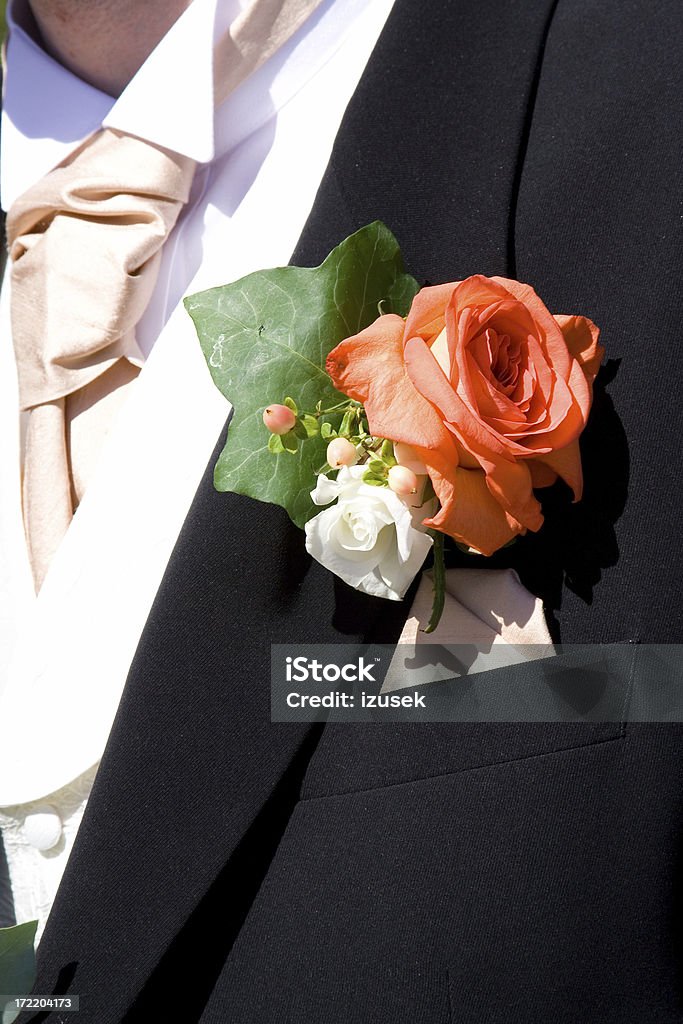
[7,0,321,590]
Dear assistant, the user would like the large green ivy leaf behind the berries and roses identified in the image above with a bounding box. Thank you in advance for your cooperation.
[185,221,418,527]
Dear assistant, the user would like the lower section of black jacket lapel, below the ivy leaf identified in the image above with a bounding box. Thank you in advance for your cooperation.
[33,467,405,1021]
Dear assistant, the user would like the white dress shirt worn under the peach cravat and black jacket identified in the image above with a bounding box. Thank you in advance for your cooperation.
[0,0,393,930]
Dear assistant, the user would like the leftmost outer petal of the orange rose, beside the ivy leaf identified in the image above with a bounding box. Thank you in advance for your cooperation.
[326,313,458,454]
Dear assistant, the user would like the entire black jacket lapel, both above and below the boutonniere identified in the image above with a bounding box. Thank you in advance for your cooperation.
[30,0,565,1024]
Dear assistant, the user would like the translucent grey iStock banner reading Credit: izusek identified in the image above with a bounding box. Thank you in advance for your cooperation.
[271,639,683,724]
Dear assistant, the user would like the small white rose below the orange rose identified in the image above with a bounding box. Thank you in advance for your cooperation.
[306,466,432,601]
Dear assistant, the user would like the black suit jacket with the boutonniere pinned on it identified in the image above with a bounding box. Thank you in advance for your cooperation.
[21,0,683,1024]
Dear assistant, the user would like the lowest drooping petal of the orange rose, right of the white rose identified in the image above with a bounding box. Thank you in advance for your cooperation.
[425,468,524,555]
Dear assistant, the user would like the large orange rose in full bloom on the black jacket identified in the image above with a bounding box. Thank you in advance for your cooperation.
[327,274,603,555]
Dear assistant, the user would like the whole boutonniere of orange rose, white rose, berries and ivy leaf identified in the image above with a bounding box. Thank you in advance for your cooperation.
[185,222,603,631]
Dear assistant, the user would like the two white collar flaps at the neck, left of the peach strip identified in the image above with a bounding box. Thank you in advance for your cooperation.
[0,0,231,210]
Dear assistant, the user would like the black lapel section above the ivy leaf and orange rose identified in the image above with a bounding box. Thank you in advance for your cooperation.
[292,0,555,284]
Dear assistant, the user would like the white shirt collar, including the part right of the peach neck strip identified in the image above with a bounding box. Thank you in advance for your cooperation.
[0,0,375,210]
